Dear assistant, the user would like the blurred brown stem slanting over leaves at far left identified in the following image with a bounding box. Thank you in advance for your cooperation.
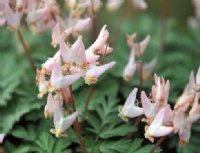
[17,30,35,72]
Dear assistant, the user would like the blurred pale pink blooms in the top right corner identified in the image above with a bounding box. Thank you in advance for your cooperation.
[189,0,200,28]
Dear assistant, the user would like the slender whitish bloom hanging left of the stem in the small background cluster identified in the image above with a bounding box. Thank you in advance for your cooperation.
[123,50,136,81]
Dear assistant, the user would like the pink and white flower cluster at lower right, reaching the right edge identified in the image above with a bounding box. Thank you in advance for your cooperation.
[119,67,200,144]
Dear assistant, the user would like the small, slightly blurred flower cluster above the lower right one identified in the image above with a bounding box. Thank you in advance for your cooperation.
[123,33,157,81]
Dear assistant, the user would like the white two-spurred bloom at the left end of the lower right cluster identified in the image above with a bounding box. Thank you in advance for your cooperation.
[119,88,144,122]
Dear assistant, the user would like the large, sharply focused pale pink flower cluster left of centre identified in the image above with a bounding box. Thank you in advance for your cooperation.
[36,23,115,137]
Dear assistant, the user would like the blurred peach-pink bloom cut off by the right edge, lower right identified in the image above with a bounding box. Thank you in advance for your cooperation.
[173,93,200,145]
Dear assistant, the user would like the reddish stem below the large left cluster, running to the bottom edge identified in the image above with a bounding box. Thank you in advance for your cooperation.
[69,85,87,153]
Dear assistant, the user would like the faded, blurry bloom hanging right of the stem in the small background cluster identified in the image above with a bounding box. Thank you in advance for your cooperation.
[142,58,157,80]
